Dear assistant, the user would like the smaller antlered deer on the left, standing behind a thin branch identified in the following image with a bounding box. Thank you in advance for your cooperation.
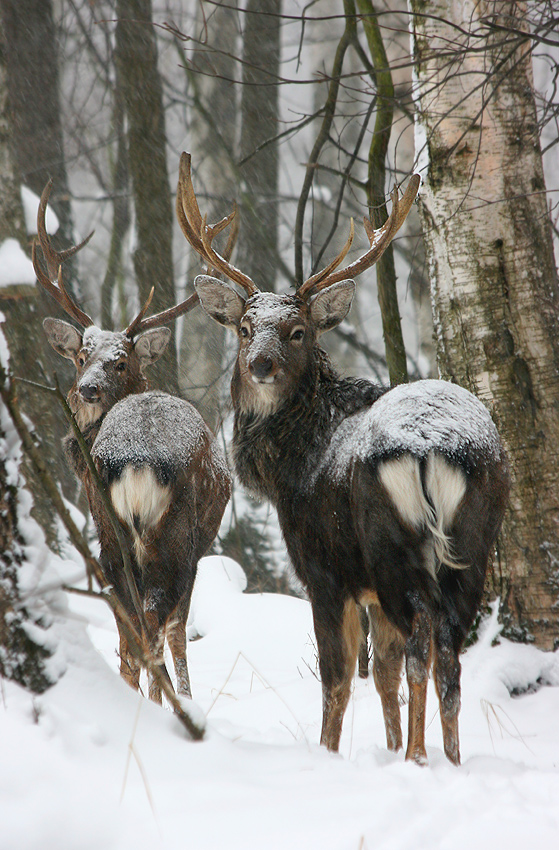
[33,183,231,702]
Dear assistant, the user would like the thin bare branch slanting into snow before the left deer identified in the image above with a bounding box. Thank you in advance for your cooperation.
[0,364,205,741]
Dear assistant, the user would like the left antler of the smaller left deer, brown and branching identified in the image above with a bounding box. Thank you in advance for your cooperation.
[31,179,94,328]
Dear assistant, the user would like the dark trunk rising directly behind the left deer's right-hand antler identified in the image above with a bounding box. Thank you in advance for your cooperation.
[115,0,178,392]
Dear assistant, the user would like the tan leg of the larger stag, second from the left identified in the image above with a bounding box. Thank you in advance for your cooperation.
[368,605,405,752]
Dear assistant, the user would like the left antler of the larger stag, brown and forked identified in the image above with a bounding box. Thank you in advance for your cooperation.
[177,152,258,297]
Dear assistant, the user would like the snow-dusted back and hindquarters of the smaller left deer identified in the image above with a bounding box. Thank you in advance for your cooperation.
[86,391,230,566]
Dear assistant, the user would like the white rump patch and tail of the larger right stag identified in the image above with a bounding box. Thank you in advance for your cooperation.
[378,453,467,576]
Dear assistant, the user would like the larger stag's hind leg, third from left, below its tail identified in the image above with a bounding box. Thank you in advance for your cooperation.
[405,610,431,765]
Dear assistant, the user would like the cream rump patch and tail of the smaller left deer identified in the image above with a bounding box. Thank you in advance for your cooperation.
[111,465,171,564]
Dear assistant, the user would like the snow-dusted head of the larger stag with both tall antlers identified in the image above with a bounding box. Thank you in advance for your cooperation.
[177,153,419,414]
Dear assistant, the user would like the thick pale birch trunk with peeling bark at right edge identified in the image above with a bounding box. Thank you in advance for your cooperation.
[411,0,559,648]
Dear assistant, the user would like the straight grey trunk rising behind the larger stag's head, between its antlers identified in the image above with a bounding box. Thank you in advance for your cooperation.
[239,0,281,290]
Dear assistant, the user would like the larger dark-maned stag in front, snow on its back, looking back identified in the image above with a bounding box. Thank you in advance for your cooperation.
[177,154,509,764]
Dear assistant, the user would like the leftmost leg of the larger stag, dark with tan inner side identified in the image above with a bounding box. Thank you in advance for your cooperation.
[313,599,362,752]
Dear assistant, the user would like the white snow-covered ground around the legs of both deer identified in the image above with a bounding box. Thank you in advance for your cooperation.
[0,544,559,850]
